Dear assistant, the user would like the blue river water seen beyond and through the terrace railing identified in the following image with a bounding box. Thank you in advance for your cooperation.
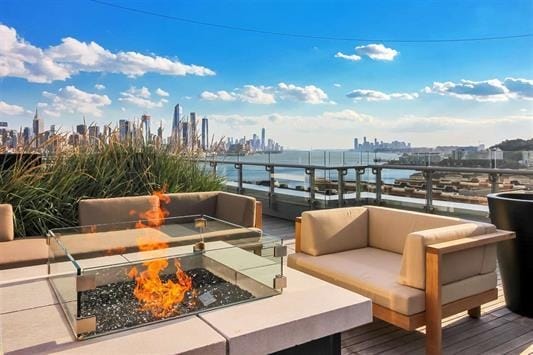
[209,150,415,188]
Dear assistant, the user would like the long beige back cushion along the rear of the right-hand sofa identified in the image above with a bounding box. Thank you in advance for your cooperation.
[367,206,464,254]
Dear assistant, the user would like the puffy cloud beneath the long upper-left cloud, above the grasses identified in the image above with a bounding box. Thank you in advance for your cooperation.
[40,85,111,117]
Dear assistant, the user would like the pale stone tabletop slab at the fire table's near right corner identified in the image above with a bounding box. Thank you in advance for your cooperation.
[199,268,372,354]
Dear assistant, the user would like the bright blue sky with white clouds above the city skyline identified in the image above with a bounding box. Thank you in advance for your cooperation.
[0,0,533,149]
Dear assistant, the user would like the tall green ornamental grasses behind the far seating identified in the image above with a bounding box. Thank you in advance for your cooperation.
[0,143,222,237]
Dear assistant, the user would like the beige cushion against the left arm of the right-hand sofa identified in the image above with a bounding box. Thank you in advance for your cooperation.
[300,207,368,256]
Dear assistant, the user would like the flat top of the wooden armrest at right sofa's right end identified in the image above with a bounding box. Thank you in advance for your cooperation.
[426,230,515,255]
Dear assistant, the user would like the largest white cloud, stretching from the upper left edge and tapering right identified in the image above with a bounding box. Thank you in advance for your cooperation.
[0,25,215,83]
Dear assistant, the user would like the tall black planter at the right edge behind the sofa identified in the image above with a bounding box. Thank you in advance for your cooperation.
[487,192,533,317]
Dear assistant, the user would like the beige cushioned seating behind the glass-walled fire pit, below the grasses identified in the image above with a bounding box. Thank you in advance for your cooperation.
[0,191,262,269]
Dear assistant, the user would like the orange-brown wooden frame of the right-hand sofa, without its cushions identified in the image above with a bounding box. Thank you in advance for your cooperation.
[294,217,515,355]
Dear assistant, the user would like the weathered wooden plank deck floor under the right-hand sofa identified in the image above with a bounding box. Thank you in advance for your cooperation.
[263,216,533,354]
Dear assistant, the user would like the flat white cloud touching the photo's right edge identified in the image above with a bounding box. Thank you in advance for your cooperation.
[423,78,533,102]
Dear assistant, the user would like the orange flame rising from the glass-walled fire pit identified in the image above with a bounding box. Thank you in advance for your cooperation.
[128,192,192,318]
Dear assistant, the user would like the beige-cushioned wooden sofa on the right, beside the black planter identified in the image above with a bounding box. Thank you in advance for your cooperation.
[288,206,514,354]
